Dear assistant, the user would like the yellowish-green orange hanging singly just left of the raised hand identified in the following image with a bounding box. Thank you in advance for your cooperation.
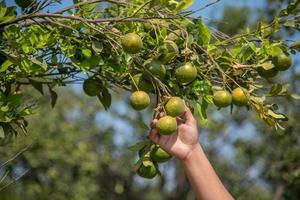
[130,91,150,110]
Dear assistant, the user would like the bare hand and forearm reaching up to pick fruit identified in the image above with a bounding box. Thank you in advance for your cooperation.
[150,107,233,200]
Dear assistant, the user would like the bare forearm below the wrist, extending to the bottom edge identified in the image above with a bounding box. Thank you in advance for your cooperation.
[182,145,233,200]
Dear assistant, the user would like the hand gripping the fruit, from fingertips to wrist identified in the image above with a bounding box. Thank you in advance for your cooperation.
[150,106,199,160]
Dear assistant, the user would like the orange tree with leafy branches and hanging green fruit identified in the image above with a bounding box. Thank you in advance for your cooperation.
[0,0,300,178]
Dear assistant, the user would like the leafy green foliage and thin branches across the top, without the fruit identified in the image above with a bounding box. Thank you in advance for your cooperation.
[0,0,299,141]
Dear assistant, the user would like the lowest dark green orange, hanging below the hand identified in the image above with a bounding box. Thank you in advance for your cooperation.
[137,158,157,179]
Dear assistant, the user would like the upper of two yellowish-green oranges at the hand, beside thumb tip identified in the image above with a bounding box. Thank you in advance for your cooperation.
[165,97,185,117]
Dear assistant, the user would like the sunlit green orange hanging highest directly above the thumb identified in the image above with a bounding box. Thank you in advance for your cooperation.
[175,62,197,84]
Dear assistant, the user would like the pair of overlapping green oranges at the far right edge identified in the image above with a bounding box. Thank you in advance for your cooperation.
[257,53,292,78]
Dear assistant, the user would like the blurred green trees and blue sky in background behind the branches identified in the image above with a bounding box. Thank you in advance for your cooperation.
[0,0,300,200]
